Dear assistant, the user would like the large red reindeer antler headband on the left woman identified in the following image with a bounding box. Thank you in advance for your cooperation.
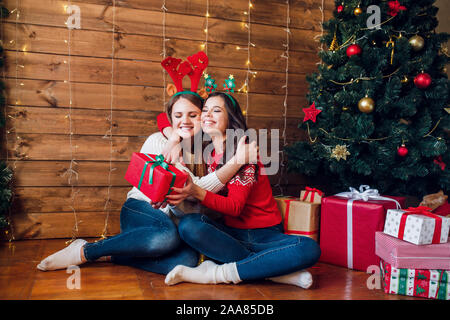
[161,51,209,99]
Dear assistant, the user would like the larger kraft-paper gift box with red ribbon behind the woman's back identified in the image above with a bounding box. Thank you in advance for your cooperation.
[275,196,320,241]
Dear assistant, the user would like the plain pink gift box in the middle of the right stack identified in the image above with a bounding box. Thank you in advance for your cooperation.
[375,232,450,270]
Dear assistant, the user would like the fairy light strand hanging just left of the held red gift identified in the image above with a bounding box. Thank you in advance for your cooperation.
[100,0,116,239]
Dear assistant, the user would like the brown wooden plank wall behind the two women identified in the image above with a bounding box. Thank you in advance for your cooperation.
[2,0,334,239]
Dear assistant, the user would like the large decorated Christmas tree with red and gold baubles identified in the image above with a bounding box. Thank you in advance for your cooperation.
[286,0,450,197]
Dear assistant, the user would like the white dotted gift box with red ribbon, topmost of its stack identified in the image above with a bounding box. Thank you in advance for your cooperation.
[384,207,450,245]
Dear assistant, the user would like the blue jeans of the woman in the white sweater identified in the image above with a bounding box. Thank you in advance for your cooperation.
[84,198,198,274]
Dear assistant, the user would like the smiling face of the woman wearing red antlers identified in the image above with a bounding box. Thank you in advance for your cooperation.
[172,98,201,139]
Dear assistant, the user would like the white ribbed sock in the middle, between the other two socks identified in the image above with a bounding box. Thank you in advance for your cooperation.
[165,260,241,286]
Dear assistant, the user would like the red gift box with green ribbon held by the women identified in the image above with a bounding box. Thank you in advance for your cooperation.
[125,152,188,202]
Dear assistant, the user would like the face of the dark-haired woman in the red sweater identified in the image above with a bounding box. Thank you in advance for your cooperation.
[201,96,228,135]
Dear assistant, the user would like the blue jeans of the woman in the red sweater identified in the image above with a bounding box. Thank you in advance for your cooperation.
[178,214,321,280]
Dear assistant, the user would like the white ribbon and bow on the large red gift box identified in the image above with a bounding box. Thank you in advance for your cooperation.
[335,185,401,269]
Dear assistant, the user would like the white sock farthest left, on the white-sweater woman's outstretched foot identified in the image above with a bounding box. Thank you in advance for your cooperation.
[37,239,87,271]
